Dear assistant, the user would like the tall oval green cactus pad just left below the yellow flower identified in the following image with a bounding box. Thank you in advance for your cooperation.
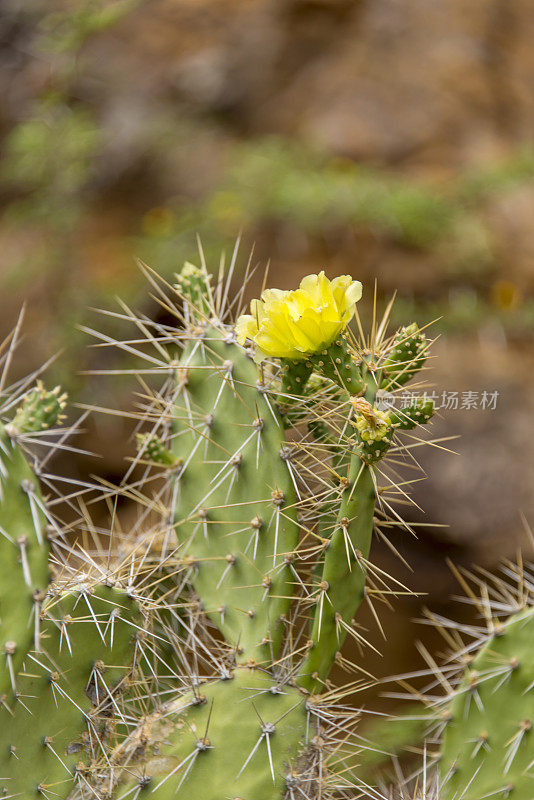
[171,328,298,661]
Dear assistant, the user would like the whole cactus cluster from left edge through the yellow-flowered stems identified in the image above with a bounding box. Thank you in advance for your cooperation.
[0,263,444,800]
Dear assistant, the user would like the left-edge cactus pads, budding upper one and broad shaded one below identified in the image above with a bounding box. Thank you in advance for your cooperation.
[0,366,153,798]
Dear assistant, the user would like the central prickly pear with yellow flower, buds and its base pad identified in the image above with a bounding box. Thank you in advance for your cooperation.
[114,264,440,800]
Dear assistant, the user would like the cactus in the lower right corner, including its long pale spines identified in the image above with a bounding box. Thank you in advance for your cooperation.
[367,558,534,800]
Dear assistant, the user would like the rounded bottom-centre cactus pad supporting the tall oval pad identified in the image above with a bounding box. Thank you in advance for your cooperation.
[113,669,308,800]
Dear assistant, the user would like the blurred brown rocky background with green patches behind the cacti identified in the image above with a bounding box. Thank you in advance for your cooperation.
[0,0,534,692]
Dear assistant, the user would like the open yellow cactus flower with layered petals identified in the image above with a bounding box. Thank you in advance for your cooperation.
[235,272,362,361]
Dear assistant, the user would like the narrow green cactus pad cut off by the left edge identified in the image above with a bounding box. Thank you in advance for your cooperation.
[0,426,49,700]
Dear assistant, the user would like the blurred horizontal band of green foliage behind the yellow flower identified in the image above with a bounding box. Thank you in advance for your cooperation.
[140,137,534,274]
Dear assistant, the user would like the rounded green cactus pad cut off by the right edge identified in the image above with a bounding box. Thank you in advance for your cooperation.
[440,608,534,800]
